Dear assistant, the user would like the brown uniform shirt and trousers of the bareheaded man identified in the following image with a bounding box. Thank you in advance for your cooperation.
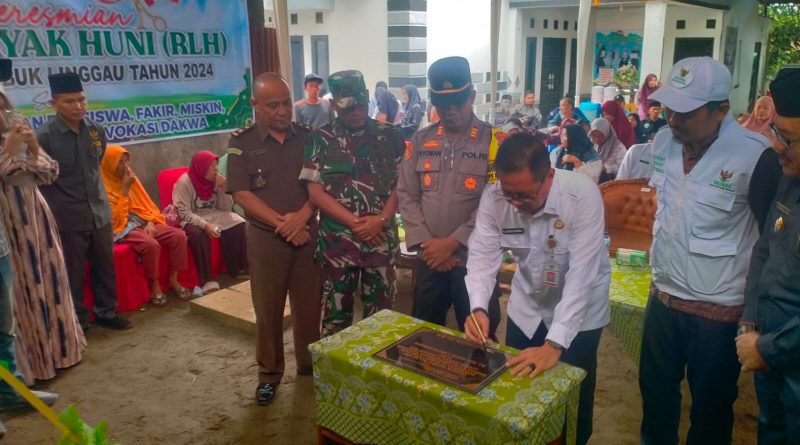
[227,123,321,385]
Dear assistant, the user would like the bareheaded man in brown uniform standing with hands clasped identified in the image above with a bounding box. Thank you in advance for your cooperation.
[227,73,321,405]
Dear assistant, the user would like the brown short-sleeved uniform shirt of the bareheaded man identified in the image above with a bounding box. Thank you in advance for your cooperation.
[226,123,316,231]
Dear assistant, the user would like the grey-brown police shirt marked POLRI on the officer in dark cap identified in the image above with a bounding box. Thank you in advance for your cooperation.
[397,117,506,266]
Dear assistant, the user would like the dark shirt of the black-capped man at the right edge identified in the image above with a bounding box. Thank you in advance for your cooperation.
[742,176,800,370]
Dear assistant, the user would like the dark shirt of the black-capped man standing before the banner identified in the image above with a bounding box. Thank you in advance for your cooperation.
[36,117,111,232]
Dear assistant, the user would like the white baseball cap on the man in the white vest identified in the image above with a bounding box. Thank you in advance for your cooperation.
[649,57,731,113]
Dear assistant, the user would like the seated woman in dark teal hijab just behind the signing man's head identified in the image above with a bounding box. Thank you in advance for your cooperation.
[550,124,603,183]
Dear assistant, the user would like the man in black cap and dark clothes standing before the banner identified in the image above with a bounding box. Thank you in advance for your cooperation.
[36,73,130,332]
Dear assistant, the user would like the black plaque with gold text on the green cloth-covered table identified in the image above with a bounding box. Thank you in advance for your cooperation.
[375,327,507,394]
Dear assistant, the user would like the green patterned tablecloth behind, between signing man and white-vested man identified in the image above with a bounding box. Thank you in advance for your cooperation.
[609,259,652,365]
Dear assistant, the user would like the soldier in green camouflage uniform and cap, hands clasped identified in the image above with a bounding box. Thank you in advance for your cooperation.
[300,71,405,336]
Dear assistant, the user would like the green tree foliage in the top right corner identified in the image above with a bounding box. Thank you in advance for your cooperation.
[766,3,800,79]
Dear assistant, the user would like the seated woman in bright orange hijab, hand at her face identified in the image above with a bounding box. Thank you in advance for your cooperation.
[100,145,191,307]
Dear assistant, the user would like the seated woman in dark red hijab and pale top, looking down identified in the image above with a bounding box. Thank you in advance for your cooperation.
[172,151,249,294]
